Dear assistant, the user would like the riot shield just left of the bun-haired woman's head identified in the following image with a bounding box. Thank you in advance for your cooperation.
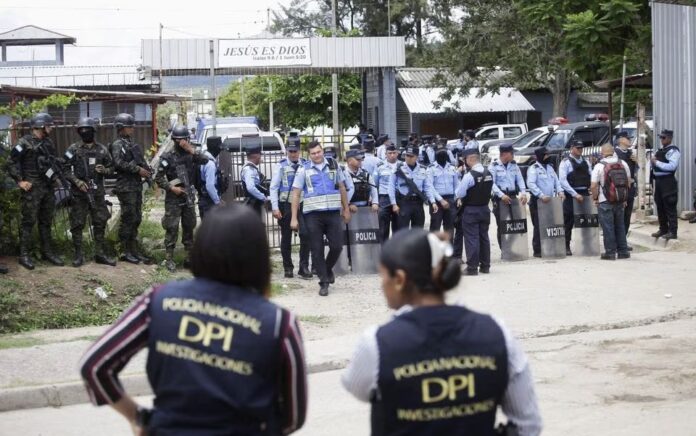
[343,206,381,274]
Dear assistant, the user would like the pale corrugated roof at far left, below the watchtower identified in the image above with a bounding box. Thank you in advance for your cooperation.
[0,65,159,88]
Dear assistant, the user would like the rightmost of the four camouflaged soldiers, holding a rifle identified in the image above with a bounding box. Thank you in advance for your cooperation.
[155,126,208,272]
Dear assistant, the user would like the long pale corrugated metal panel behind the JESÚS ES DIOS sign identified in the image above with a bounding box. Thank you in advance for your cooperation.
[141,36,406,75]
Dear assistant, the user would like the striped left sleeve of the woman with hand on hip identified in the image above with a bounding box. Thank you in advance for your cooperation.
[80,288,155,406]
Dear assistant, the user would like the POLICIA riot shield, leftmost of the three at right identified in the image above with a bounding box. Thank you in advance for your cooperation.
[500,198,529,261]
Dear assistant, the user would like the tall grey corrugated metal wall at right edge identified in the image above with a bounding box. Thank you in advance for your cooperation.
[652,2,696,210]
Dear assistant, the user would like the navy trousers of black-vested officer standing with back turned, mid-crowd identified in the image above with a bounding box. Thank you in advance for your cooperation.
[462,206,491,271]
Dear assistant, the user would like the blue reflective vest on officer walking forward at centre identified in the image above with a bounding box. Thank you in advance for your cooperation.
[302,159,342,214]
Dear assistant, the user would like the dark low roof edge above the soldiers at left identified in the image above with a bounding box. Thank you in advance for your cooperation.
[0,85,189,104]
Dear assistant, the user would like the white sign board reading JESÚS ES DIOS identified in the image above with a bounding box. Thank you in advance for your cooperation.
[218,38,312,68]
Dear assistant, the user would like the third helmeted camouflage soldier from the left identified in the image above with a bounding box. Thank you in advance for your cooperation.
[109,114,152,264]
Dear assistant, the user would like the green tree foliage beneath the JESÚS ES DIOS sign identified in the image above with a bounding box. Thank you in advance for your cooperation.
[218,74,361,130]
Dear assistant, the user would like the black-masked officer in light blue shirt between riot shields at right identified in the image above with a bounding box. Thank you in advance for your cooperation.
[527,147,565,257]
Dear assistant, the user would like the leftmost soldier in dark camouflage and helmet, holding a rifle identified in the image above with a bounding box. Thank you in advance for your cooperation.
[7,113,63,270]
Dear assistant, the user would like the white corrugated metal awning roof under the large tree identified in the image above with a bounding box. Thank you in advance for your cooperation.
[399,88,534,114]
